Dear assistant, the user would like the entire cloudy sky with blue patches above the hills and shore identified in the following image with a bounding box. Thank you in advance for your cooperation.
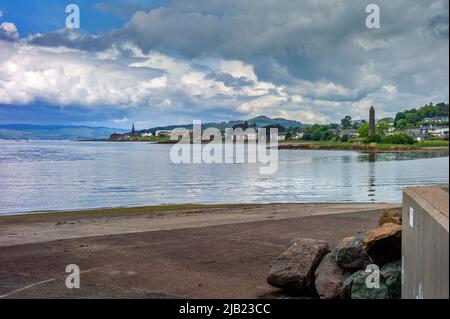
[0,0,449,129]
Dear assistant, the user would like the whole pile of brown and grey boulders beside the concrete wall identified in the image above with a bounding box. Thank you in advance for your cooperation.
[267,210,402,299]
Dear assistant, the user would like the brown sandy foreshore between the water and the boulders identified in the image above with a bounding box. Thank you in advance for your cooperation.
[0,203,400,298]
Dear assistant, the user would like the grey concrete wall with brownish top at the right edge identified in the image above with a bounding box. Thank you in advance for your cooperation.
[402,185,449,299]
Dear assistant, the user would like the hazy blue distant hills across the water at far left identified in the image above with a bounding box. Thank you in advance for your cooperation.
[0,124,127,140]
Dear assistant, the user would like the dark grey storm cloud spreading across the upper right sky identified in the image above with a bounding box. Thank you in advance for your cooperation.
[28,0,448,91]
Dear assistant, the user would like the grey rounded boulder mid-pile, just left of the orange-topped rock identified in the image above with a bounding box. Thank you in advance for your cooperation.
[335,234,370,269]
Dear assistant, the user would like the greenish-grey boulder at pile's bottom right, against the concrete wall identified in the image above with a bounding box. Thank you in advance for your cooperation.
[351,261,401,299]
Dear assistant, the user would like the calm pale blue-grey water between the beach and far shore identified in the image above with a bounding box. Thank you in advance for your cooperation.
[0,141,449,214]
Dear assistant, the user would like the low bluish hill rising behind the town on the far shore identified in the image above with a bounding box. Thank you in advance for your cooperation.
[140,115,308,132]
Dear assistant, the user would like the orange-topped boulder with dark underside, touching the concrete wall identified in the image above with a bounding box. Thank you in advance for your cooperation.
[363,223,402,267]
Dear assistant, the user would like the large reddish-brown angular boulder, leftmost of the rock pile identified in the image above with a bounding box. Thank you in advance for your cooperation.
[267,238,330,292]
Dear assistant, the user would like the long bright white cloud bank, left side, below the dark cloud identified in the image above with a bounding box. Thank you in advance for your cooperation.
[0,41,310,123]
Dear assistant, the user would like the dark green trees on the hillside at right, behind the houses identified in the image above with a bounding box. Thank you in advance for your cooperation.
[394,103,448,130]
